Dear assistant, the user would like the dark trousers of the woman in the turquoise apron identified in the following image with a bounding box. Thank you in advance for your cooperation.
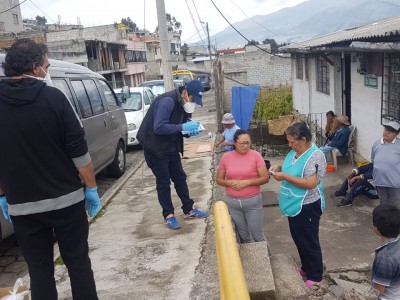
[288,199,323,282]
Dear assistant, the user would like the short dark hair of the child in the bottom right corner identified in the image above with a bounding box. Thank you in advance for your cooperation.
[372,204,400,238]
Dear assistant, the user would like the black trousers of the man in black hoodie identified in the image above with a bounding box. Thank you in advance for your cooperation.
[11,201,98,300]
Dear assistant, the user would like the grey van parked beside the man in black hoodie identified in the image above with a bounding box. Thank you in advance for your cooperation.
[0,54,128,240]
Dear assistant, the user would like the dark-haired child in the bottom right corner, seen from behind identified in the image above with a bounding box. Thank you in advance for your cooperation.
[371,204,400,300]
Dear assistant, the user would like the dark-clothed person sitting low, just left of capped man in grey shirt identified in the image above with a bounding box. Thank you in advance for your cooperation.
[332,163,379,207]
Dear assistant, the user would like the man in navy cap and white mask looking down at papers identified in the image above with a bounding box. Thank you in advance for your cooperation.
[137,80,208,229]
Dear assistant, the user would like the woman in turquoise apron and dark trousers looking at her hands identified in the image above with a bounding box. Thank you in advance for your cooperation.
[270,123,326,287]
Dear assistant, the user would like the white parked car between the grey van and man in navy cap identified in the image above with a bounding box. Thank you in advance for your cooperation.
[114,87,155,146]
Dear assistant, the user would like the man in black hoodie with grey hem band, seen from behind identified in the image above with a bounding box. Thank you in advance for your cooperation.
[0,39,101,300]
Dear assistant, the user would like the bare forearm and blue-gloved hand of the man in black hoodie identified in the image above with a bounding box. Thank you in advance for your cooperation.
[78,163,101,217]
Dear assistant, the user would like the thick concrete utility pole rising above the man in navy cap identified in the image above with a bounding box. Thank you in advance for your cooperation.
[156,0,174,91]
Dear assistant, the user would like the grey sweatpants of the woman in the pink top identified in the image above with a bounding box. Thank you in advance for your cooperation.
[226,194,266,243]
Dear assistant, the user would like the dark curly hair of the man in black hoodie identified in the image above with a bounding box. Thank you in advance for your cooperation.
[1,38,48,77]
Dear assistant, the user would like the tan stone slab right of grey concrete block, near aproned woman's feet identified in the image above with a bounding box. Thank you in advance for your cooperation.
[269,254,309,300]
